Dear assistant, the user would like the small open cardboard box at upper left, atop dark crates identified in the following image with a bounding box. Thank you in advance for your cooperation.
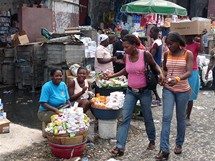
[11,31,29,46]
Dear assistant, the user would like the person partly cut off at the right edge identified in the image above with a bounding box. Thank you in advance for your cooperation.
[205,48,215,90]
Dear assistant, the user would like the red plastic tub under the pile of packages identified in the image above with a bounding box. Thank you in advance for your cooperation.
[48,141,86,159]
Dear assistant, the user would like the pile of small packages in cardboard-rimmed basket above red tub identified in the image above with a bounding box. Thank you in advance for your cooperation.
[45,107,89,145]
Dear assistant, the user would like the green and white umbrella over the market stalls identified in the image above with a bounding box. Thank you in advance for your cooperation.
[120,0,187,16]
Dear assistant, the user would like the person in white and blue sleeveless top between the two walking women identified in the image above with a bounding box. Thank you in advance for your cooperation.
[150,26,162,105]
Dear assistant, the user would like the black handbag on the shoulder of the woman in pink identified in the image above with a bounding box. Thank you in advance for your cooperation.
[144,51,158,90]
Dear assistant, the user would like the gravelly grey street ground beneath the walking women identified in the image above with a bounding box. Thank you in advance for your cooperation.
[0,91,215,161]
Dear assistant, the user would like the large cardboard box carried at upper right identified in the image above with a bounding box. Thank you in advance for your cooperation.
[170,20,211,35]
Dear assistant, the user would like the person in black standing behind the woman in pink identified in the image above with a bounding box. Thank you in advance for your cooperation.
[113,29,129,73]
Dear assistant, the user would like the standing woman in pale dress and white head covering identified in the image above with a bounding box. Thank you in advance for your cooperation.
[95,34,116,73]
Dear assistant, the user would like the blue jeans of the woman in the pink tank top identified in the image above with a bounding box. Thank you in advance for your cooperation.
[116,89,156,149]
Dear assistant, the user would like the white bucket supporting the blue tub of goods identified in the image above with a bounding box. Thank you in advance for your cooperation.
[98,120,117,139]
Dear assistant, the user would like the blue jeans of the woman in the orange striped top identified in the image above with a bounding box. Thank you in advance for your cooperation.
[160,88,189,152]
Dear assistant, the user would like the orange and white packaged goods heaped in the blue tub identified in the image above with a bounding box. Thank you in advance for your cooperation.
[92,91,125,110]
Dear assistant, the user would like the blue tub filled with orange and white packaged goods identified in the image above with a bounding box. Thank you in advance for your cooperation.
[91,91,125,120]
